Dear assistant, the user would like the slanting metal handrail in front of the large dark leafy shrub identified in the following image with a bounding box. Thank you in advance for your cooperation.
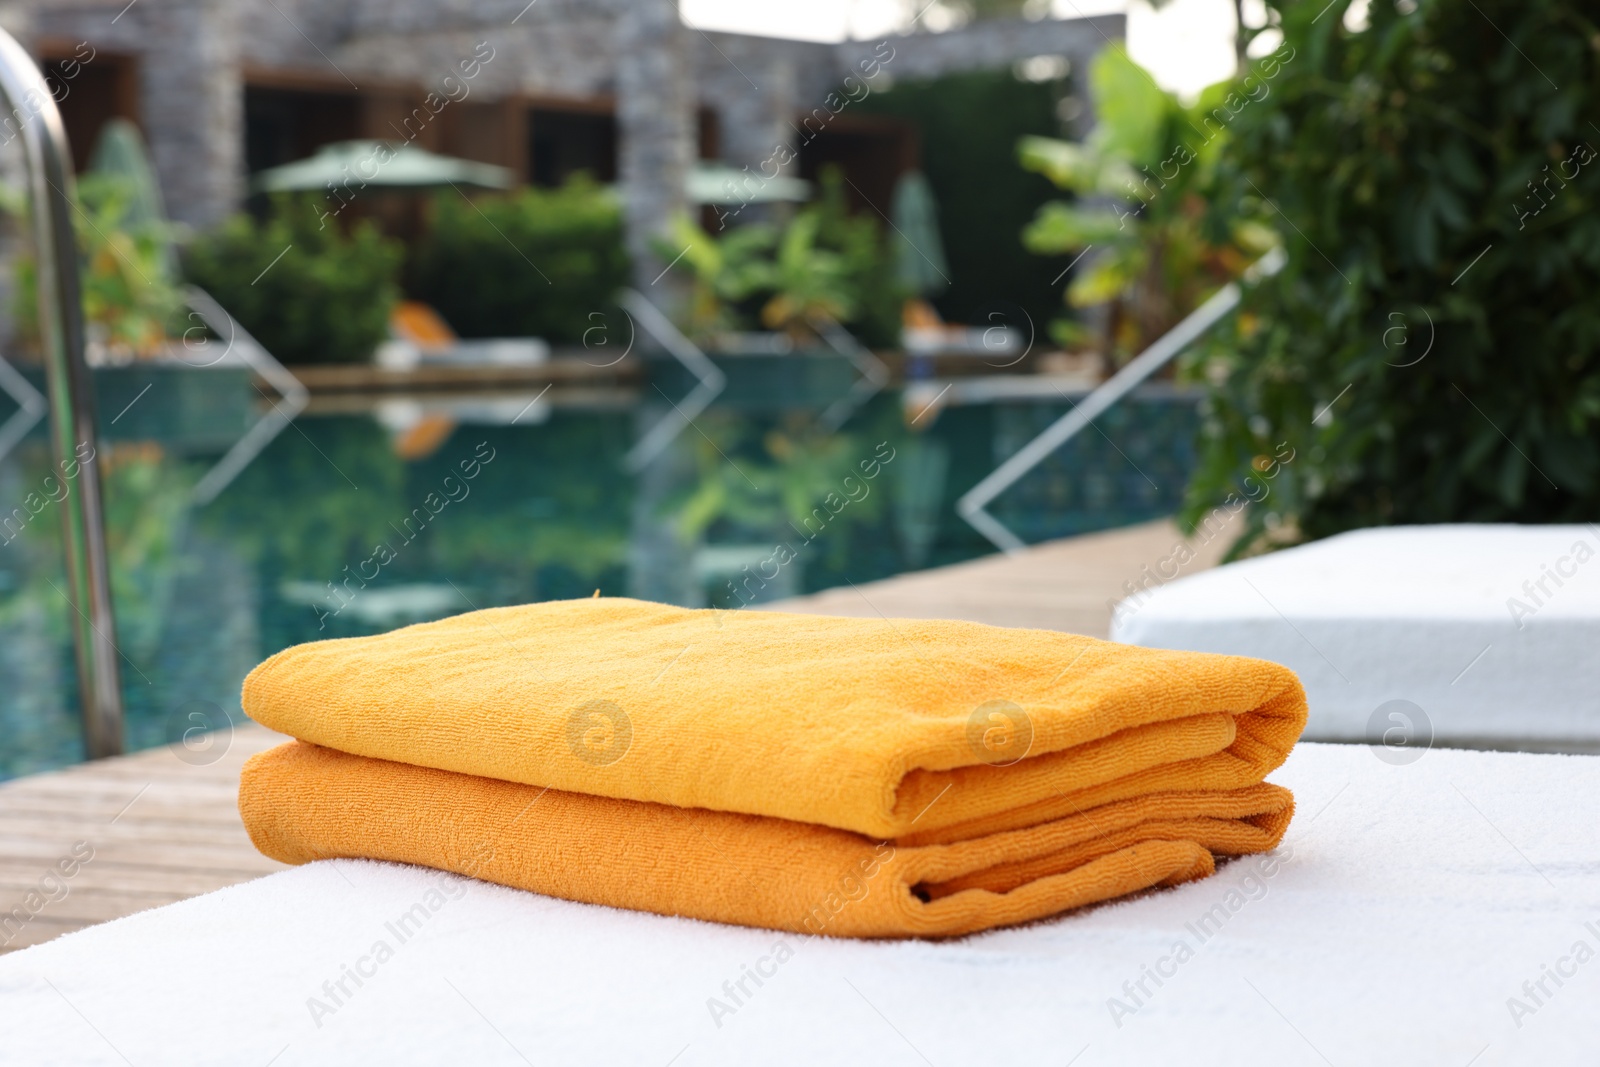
[955,248,1286,553]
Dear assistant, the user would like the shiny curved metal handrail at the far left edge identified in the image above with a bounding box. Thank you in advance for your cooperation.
[0,30,122,760]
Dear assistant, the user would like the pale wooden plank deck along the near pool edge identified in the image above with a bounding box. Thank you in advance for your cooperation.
[0,522,1230,952]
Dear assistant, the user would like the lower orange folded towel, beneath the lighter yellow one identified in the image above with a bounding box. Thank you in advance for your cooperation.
[238,742,1293,937]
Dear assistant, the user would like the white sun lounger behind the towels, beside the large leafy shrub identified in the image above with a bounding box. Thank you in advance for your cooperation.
[1112,526,1600,745]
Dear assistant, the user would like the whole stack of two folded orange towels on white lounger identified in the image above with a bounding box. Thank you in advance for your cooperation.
[238,598,1306,937]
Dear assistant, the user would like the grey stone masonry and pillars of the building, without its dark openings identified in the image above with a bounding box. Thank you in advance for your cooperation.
[3,0,1123,241]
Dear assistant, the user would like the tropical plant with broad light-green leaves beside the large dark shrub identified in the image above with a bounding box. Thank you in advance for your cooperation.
[1019,46,1275,363]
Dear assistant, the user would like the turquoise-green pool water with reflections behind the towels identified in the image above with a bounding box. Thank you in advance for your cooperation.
[0,360,1197,777]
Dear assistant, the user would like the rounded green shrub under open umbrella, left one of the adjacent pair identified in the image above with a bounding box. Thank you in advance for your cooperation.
[184,197,402,363]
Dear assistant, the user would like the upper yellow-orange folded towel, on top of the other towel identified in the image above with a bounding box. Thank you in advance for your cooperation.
[243,598,1306,844]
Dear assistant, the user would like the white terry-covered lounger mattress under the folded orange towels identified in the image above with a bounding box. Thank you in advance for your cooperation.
[0,745,1600,1067]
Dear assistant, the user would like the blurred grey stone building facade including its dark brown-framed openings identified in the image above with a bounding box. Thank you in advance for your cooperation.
[0,0,1123,279]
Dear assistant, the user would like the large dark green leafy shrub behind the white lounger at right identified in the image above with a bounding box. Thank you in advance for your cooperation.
[1184,0,1600,547]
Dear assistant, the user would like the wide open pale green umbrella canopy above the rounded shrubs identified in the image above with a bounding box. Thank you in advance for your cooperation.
[251,141,517,192]
